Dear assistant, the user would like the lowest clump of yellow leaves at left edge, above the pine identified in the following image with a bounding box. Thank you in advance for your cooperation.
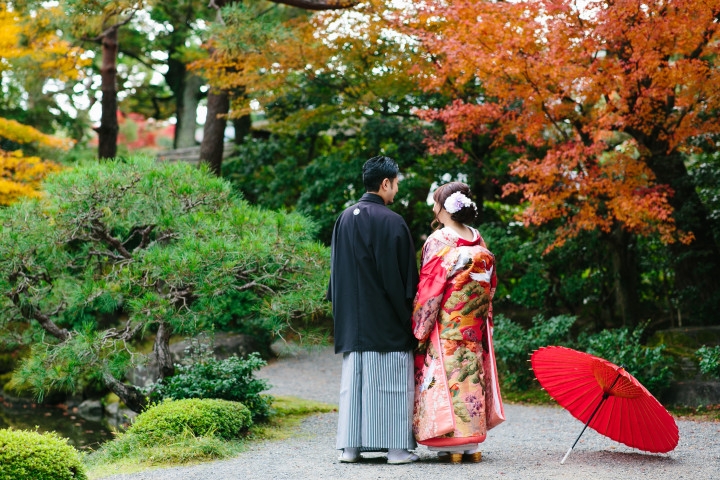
[0,150,62,206]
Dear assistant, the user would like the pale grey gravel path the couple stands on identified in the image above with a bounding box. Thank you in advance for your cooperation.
[101,348,720,480]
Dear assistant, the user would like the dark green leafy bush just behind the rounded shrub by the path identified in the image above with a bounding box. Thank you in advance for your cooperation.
[151,353,273,419]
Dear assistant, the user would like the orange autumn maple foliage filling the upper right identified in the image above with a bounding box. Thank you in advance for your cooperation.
[399,0,720,255]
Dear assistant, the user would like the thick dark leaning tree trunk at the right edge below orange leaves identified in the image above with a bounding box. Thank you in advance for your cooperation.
[647,153,720,325]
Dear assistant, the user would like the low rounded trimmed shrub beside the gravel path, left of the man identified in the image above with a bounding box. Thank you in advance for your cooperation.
[127,398,252,445]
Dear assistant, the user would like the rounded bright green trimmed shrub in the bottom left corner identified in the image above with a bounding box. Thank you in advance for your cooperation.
[0,428,87,480]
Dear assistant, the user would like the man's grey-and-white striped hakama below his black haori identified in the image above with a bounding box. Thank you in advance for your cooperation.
[336,351,416,452]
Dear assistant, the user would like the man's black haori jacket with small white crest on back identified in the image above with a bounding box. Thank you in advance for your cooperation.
[327,193,418,353]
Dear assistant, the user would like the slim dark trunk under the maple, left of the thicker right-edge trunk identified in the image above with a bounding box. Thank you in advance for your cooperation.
[609,227,639,327]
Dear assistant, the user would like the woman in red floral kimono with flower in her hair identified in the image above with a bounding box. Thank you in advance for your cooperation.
[413,182,502,463]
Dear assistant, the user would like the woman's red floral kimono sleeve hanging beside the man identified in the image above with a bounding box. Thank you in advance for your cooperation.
[412,237,448,341]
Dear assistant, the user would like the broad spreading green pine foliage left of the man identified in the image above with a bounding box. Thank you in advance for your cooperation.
[0,158,329,402]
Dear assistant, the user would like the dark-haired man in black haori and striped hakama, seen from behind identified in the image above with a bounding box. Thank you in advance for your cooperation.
[327,157,418,463]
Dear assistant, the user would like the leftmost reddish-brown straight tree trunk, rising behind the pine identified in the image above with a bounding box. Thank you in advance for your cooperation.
[97,27,119,159]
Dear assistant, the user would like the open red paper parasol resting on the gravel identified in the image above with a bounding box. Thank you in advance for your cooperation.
[531,347,679,463]
